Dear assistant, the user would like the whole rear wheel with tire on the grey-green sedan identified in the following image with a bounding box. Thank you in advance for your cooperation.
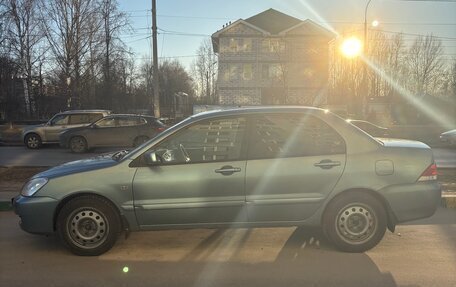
[323,192,387,252]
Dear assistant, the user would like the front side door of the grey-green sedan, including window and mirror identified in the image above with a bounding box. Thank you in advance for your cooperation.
[133,117,247,229]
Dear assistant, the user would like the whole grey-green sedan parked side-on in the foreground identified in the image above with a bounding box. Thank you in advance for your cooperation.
[13,107,441,255]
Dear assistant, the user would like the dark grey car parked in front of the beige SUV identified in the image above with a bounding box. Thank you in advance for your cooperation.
[60,114,166,153]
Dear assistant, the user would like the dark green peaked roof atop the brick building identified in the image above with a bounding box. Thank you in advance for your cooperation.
[245,8,302,35]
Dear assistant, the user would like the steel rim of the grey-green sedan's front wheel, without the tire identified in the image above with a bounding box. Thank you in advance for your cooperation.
[67,209,109,249]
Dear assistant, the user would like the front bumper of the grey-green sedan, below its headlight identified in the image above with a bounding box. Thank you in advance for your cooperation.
[12,195,59,234]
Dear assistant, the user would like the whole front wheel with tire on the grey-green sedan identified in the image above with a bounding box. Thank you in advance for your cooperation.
[57,195,121,256]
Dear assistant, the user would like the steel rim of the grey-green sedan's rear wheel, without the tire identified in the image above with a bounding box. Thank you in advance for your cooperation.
[336,203,378,244]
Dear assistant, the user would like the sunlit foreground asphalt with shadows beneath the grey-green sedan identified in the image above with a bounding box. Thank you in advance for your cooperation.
[0,209,456,287]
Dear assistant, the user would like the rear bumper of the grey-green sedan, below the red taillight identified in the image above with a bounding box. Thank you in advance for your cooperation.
[380,181,442,223]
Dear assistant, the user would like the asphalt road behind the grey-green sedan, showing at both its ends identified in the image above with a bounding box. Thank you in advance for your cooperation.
[0,145,456,168]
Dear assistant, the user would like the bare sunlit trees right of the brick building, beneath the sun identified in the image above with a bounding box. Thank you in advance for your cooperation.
[329,31,456,123]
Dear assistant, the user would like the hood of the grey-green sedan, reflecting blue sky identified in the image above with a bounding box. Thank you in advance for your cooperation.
[33,153,118,179]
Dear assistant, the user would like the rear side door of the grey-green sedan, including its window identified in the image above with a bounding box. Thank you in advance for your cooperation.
[246,114,345,222]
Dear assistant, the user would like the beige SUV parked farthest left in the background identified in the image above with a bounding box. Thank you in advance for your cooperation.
[22,110,111,149]
